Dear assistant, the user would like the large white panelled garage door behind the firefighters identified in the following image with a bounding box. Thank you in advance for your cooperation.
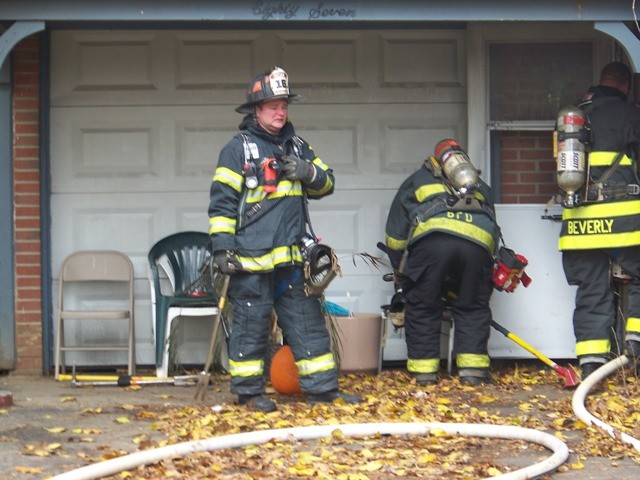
[51,30,467,365]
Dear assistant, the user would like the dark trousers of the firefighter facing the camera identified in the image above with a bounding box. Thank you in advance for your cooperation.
[229,267,338,395]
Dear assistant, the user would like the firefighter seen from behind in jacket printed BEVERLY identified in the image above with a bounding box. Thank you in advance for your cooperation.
[558,62,640,378]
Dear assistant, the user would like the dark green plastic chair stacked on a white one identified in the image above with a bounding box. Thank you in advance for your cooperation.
[149,232,218,378]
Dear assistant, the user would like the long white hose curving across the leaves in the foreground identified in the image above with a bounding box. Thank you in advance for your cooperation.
[51,423,569,480]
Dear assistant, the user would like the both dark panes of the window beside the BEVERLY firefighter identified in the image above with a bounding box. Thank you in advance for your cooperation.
[490,42,593,203]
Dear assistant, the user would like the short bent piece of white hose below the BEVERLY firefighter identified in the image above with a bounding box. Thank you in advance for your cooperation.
[571,355,640,451]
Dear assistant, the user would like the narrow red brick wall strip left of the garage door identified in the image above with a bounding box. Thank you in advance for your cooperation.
[11,35,43,373]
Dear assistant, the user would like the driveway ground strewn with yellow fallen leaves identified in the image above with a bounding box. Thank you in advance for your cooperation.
[0,361,640,480]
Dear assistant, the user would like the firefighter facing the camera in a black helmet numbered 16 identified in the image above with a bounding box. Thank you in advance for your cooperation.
[209,67,360,412]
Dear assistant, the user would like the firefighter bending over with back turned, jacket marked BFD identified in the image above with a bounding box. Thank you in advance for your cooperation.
[386,140,500,385]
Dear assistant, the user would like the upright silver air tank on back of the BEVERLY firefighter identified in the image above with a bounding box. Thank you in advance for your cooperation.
[553,105,588,208]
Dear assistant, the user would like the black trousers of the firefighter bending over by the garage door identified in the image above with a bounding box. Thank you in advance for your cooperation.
[405,233,493,373]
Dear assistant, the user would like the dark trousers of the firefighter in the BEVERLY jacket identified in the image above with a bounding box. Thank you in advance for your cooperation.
[562,247,640,364]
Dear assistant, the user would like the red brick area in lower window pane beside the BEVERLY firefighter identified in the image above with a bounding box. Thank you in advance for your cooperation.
[499,131,558,203]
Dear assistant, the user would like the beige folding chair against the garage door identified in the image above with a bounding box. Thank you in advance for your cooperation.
[54,250,136,380]
